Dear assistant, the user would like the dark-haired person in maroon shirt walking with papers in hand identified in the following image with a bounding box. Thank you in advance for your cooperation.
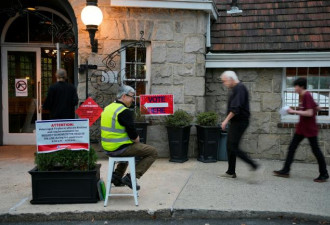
[274,78,329,182]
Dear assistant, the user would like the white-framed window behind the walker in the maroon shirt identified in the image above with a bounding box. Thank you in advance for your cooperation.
[282,67,330,122]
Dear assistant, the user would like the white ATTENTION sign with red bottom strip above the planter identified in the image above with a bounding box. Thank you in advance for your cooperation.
[36,119,89,153]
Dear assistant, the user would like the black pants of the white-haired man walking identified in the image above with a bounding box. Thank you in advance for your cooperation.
[227,121,257,174]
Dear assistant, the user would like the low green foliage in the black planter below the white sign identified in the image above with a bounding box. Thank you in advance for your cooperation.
[35,147,97,171]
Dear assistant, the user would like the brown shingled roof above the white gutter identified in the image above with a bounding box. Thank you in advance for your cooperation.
[211,0,330,52]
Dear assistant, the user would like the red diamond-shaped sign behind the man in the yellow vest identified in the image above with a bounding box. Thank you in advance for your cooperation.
[76,97,103,126]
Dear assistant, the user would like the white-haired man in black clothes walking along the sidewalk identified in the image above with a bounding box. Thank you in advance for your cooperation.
[220,71,259,178]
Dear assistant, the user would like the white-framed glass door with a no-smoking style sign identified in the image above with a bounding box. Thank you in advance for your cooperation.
[2,47,41,145]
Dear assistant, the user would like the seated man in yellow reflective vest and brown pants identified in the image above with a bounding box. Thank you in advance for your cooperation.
[101,85,158,190]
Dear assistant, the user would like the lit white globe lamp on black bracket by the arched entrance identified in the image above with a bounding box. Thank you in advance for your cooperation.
[81,0,103,52]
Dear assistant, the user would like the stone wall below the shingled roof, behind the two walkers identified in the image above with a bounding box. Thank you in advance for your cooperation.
[206,68,330,162]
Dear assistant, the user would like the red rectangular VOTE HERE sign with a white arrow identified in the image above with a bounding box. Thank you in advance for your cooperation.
[140,95,173,115]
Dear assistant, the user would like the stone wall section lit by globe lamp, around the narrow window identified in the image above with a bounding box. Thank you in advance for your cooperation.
[70,0,208,157]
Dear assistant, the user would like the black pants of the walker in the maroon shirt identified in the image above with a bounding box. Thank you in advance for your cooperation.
[283,134,327,175]
